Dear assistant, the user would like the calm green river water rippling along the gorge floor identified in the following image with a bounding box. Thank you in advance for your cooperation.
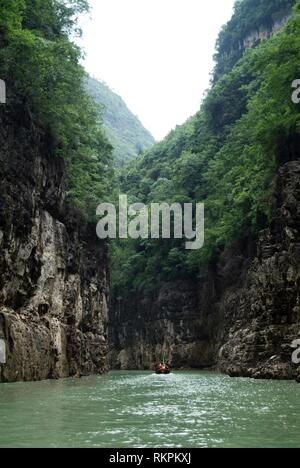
[0,372,300,448]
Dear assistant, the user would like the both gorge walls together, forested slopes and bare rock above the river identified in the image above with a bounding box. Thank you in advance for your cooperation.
[0,0,300,388]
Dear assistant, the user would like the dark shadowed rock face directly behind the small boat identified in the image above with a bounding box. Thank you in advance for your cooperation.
[109,282,212,369]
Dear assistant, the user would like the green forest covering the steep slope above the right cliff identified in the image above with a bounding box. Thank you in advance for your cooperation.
[112,0,300,296]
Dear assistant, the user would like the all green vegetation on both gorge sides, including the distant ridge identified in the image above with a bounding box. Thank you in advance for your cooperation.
[0,0,300,302]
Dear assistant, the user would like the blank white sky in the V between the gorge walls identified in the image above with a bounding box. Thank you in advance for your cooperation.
[82,0,235,140]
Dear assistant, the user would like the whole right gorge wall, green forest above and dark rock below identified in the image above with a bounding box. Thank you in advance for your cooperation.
[109,2,300,380]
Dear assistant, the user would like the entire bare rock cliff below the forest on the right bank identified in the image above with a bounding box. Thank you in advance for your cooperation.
[110,159,300,378]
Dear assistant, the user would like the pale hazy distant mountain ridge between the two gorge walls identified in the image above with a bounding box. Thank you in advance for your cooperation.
[87,78,155,166]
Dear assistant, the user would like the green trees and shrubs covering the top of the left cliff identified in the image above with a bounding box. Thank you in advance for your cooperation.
[0,0,112,217]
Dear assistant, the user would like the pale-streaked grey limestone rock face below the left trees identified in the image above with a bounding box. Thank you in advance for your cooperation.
[0,108,108,382]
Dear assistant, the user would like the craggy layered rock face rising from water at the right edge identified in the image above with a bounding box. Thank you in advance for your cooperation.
[218,160,300,378]
